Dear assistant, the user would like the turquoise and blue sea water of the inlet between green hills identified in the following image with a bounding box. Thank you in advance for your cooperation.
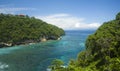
[0,31,94,71]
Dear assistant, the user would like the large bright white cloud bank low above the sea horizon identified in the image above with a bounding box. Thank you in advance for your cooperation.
[36,14,101,30]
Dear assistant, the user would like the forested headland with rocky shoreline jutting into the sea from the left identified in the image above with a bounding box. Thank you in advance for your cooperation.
[0,13,65,47]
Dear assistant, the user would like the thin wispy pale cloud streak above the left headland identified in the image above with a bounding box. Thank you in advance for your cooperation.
[0,8,35,13]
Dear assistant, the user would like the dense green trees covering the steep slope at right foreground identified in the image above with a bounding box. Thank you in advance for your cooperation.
[49,13,120,71]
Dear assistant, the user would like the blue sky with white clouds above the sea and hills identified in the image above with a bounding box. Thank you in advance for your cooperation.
[0,0,120,30]
